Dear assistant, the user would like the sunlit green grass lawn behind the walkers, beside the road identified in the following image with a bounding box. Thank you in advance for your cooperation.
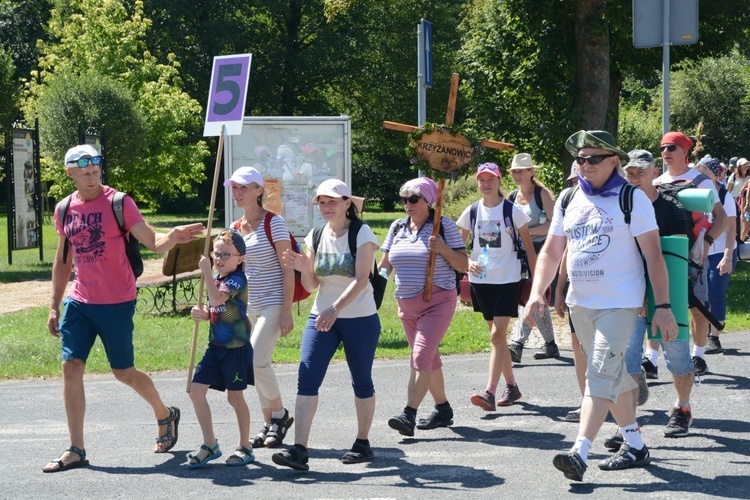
[0,212,750,380]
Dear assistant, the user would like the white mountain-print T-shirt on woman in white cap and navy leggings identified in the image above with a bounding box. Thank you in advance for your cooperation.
[305,224,379,318]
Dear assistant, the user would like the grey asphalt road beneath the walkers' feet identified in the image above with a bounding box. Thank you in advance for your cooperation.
[0,332,750,499]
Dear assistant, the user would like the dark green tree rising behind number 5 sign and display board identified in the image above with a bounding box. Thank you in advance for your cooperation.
[146,0,464,208]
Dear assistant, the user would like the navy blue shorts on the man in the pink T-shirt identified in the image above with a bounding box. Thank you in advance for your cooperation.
[60,297,135,370]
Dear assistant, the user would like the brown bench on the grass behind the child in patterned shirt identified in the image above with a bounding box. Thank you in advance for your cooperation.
[136,237,206,314]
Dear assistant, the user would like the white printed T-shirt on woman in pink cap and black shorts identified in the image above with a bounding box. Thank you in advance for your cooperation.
[456,198,531,285]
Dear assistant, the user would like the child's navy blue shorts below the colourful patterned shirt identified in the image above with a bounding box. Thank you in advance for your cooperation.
[193,342,255,392]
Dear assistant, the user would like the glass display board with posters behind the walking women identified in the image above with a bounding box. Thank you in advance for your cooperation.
[224,115,351,237]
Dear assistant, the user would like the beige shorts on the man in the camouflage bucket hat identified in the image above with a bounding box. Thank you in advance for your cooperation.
[570,306,638,402]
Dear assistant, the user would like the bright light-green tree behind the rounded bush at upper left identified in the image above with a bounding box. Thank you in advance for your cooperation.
[25,0,208,206]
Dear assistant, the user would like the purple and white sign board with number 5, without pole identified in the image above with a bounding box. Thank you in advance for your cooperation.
[203,54,252,135]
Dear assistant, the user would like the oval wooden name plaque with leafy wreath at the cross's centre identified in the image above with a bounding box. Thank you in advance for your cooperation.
[406,122,484,180]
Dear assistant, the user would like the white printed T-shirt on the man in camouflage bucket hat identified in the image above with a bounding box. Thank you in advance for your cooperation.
[550,185,659,309]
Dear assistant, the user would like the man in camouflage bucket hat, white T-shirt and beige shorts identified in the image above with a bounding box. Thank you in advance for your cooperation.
[524,130,677,481]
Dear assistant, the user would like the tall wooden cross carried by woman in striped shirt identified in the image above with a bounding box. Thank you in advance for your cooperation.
[383,73,513,302]
